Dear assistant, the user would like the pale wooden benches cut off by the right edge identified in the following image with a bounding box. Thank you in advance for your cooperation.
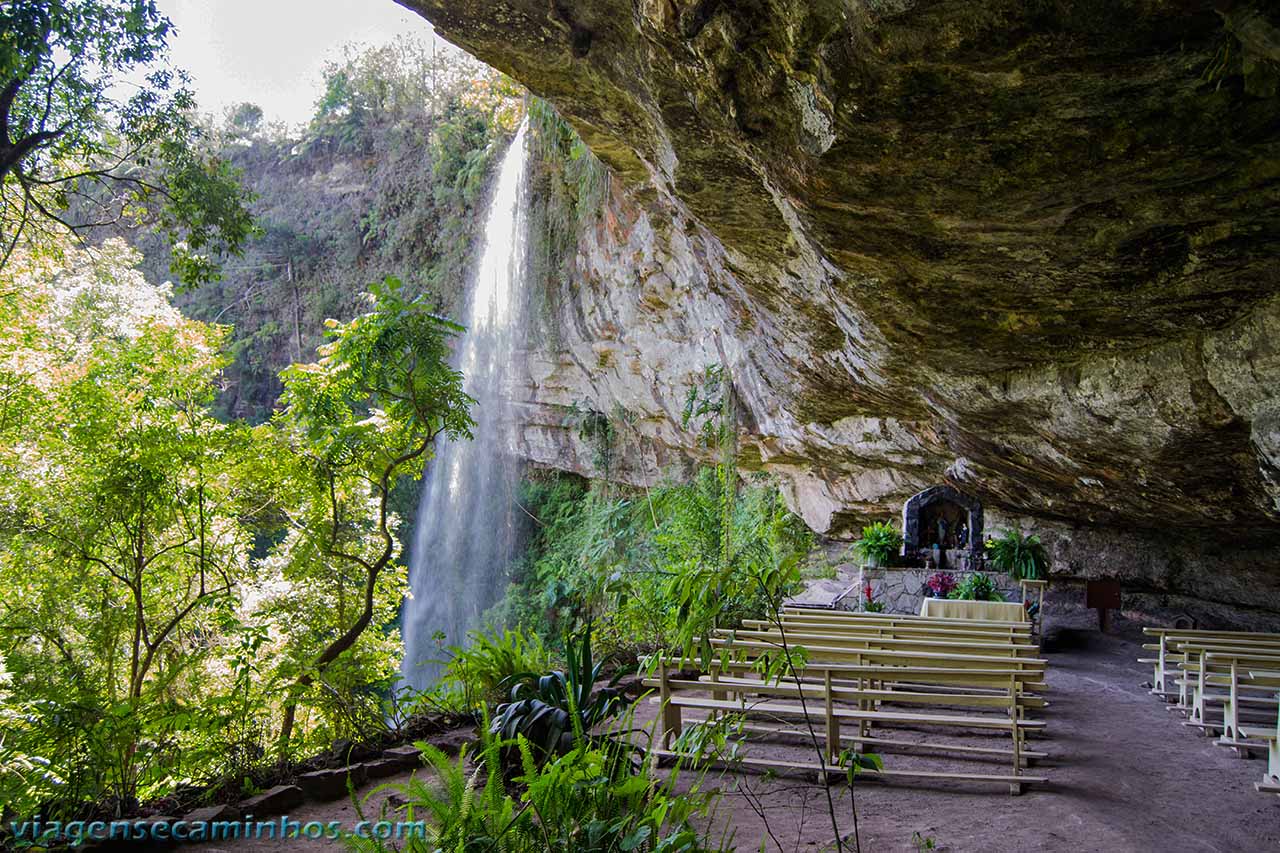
[1138,628,1280,793]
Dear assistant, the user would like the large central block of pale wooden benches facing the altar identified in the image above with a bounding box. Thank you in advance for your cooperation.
[645,608,1048,793]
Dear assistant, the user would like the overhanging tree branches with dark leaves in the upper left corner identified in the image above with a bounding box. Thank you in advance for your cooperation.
[0,0,252,284]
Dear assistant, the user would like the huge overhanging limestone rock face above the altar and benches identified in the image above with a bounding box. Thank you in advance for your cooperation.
[401,0,1280,605]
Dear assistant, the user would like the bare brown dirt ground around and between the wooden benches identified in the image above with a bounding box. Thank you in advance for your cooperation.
[215,630,1280,853]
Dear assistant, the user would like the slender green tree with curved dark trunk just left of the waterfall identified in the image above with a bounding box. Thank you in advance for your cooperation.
[274,279,474,751]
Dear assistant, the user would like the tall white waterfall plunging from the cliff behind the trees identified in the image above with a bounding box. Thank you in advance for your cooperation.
[402,119,529,689]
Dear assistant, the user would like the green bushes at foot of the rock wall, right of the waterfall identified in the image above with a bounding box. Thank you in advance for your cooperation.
[490,467,812,656]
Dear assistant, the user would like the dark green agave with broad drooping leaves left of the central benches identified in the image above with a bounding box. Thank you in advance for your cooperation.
[489,622,631,757]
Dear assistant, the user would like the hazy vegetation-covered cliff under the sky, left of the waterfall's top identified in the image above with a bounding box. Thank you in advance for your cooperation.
[125,40,522,421]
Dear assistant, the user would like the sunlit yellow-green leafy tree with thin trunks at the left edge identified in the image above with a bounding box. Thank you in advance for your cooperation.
[0,235,260,804]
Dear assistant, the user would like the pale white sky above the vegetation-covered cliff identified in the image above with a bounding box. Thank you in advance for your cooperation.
[157,0,444,126]
